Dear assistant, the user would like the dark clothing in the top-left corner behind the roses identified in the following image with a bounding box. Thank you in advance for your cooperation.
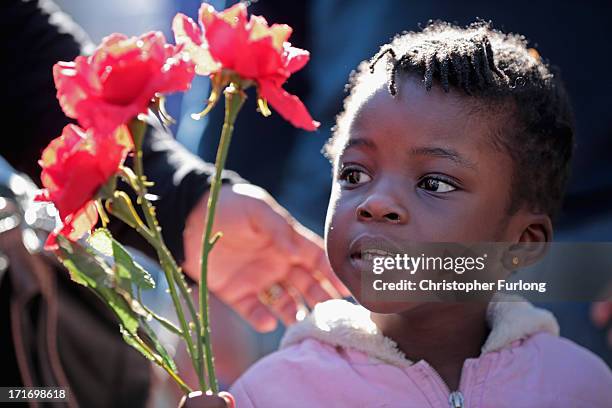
[0,0,87,179]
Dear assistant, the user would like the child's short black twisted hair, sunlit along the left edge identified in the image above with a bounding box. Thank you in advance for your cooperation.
[325,21,574,217]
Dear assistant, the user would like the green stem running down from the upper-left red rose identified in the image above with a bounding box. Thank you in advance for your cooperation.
[130,120,206,389]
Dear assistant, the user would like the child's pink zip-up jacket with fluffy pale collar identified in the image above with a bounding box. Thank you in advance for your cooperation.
[230,300,612,408]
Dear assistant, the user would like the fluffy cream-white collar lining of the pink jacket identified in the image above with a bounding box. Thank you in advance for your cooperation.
[280,295,559,367]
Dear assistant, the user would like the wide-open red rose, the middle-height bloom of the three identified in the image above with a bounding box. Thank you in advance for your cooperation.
[53,32,194,133]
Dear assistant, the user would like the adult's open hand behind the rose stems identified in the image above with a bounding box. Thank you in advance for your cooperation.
[182,184,348,332]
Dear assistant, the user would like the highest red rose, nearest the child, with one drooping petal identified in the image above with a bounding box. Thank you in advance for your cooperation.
[172,3,319,130]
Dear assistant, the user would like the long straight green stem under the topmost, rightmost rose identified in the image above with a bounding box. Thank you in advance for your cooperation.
[199,83,246,394]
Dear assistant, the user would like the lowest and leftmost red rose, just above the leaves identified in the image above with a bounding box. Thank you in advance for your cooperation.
[36,125,132,249]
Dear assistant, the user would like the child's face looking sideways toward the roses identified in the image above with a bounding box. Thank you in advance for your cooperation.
[325,78,540,313]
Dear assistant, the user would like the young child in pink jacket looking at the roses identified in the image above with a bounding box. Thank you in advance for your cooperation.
[231,23,612,408]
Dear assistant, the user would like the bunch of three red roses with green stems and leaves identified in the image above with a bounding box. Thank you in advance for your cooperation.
[37,3,318,393]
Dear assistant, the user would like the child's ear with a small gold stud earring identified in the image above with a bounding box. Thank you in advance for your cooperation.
[507,213,553,268]
